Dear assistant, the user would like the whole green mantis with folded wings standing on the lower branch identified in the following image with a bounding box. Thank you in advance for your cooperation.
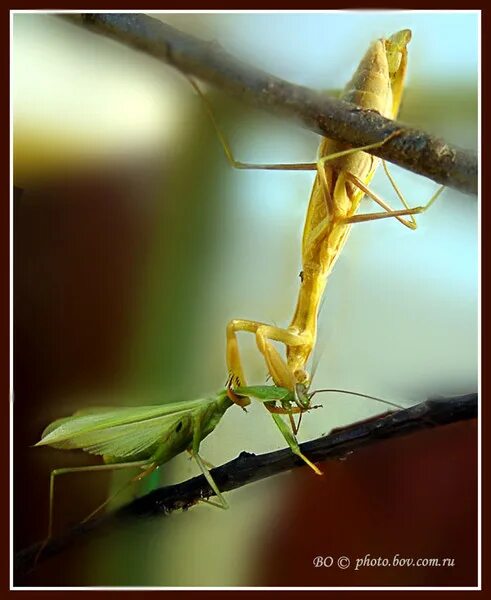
[35,384,401,556]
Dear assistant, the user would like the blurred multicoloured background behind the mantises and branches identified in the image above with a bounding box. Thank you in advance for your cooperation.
[12,11,479,586]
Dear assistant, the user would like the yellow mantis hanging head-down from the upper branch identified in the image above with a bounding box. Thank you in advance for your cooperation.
[191,29,443,438]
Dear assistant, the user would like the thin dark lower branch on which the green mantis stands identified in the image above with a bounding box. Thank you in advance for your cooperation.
[15,393,477,577]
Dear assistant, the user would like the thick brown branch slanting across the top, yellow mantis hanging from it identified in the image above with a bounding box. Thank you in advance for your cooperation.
[56,13,477,194]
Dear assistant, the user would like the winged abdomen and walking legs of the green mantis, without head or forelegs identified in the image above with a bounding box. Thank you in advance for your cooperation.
[35,390,233,539]
